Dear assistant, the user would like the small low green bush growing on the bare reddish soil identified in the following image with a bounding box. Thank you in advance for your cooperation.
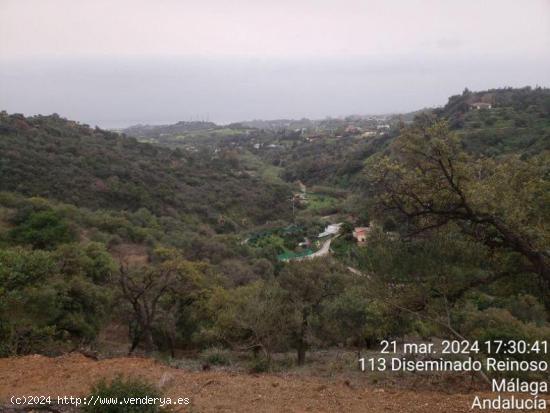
[83,376,168,413]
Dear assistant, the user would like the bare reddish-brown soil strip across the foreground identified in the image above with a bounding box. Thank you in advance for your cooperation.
[0,354,548,413]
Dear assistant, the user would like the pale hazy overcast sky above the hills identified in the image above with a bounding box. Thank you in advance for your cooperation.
[0,0,550,128]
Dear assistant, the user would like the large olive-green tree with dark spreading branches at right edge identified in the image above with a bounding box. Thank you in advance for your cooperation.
[369,123,550,294]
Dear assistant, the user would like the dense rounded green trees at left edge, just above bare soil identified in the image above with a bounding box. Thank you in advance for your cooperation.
[0,248,110,355]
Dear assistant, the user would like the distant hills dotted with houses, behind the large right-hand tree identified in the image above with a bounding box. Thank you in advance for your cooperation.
[125,88,550,189]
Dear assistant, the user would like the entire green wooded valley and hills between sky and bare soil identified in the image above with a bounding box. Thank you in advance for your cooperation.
[0,88,550,378]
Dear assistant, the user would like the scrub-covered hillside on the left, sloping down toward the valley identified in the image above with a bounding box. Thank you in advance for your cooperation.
[0,112,294,222]
